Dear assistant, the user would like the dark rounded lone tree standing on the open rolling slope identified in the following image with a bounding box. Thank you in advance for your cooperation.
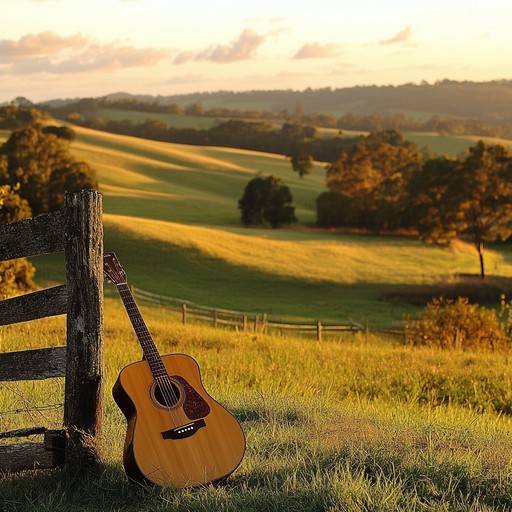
[238,175,297,228]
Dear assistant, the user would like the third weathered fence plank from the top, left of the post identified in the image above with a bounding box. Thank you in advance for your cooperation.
[0,347,66,382]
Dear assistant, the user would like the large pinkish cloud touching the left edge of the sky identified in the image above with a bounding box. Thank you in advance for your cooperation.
[0,32,87,58]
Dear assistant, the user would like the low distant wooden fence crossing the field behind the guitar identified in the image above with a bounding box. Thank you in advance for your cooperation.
[131,286,404,341]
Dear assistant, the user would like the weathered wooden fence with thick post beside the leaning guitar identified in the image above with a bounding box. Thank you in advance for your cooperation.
[0,190,103,471]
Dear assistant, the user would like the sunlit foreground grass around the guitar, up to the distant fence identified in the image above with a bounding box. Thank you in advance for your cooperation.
[0,299,512,512]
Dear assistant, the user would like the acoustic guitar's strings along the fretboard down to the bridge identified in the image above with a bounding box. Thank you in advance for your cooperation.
[117,283,188,427]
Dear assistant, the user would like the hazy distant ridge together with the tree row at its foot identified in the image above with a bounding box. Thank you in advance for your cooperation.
[42,80,512,138]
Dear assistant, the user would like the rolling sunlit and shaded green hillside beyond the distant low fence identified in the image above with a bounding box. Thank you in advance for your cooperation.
[0,128,504,325]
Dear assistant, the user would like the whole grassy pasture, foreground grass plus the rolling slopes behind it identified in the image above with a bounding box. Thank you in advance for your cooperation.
[0,123,512,512]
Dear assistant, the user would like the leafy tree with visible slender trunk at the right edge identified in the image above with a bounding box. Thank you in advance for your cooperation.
[410,141,512,279]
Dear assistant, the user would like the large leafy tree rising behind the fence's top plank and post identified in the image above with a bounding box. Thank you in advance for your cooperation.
[0,126,97,215]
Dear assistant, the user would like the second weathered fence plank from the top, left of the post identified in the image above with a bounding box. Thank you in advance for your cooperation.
[0,285,67,325]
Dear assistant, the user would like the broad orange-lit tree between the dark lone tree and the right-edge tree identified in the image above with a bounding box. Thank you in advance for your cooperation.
[327,130,423,232]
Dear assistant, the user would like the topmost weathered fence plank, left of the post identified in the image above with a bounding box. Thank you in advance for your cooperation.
[0,210,65,261]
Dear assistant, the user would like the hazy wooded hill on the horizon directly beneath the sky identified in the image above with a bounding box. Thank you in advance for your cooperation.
[41,80,512,125]
